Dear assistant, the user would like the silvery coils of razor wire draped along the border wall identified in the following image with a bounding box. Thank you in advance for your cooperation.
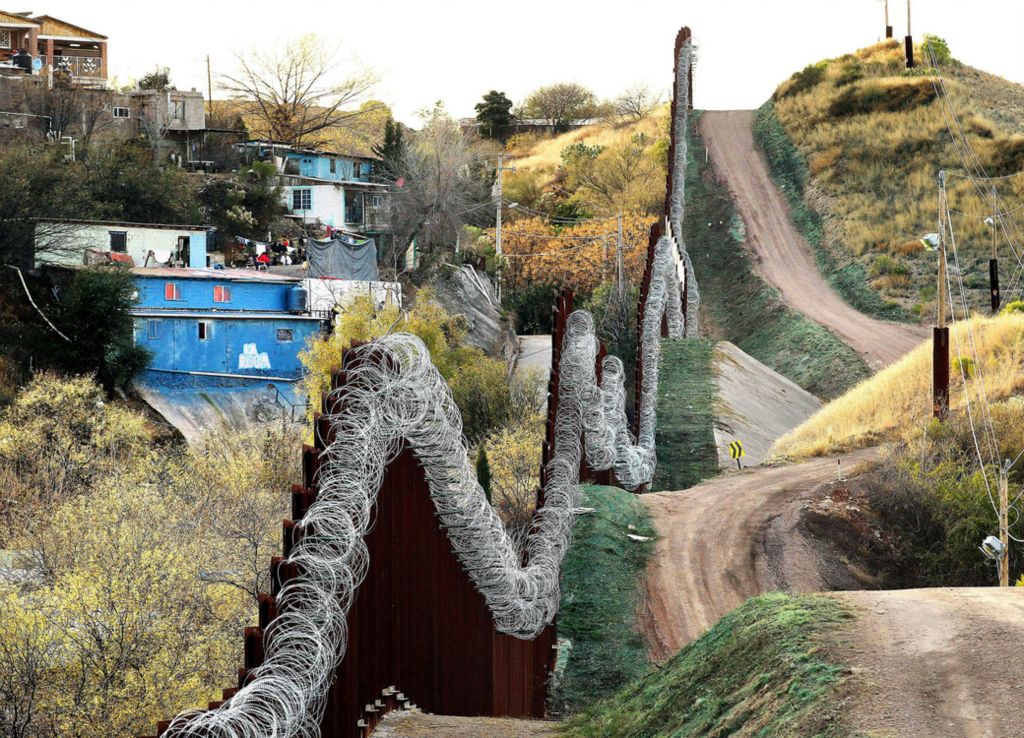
[164,236,684,738]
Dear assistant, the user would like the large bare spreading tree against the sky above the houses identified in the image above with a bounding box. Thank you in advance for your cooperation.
[221,34,377,145]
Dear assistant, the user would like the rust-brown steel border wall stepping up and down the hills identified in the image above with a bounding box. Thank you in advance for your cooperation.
[149,28,692,738]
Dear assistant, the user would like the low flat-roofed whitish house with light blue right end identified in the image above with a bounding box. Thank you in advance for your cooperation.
[34,220,212,269]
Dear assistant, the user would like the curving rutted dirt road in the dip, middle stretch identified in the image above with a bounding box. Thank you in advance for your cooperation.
[640,449,874,662]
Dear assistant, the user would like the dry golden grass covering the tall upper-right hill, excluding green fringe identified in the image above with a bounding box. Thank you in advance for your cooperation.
[775,42,1024,314]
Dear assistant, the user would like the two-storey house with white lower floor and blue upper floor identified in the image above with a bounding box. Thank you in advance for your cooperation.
[239,141,389,235]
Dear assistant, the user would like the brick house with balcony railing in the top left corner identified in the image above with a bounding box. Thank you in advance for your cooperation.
[0,10,108,87]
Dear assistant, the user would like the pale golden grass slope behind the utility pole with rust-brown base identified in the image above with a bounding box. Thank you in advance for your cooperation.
[771,314,1024,460]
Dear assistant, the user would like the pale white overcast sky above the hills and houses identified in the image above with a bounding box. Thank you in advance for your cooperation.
[36,0,1024,125]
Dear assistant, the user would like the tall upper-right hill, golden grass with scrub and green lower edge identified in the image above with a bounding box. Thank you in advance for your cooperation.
[755,41,1024,317]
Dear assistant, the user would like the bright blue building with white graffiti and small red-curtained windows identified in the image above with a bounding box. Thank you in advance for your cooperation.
[132,268,323,442]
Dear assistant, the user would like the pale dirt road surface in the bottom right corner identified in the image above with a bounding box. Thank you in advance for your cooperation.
[836,588,1024,738]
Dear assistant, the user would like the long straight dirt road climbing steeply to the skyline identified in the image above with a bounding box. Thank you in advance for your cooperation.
[700,111,927,368]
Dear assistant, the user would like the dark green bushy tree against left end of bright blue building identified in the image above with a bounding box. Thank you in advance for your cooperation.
[54,266,150,392]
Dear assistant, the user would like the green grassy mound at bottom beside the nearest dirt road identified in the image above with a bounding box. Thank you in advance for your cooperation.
[562,594,850,738]
